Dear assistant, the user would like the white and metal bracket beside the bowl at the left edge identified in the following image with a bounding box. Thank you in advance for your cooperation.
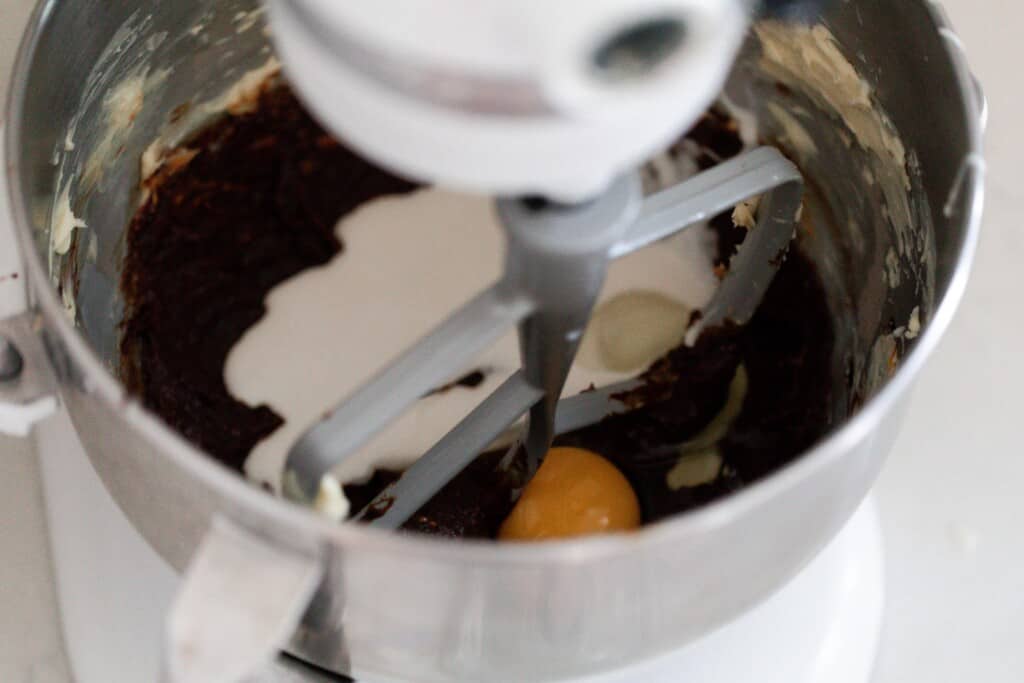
[0,143,57,436]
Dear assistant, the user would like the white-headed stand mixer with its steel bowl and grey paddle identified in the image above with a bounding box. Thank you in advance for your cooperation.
[0,0,984,681]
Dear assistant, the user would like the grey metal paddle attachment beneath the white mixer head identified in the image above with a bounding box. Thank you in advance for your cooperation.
[286,147,804,528]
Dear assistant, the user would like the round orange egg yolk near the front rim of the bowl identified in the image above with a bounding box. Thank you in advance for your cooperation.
[498,449,640,541]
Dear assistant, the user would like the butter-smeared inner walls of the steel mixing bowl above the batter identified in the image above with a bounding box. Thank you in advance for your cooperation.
[29,1,948,446]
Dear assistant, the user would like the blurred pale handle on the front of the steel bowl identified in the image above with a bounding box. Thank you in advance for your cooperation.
[161,517,324,683]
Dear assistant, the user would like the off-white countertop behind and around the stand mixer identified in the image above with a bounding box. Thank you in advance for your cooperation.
[0,0,1024,683]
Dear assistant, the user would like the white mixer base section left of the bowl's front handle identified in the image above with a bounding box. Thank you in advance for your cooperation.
[35,415,177,683]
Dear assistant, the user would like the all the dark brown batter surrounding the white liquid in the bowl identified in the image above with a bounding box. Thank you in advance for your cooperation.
[122,85,834,538]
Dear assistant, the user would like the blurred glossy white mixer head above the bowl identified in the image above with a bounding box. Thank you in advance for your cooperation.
[269,0,752,201]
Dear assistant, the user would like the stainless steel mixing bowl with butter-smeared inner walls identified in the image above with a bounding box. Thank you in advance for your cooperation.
[0,0,984,681]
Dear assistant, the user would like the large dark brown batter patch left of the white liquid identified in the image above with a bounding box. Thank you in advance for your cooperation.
[121,82,414,470]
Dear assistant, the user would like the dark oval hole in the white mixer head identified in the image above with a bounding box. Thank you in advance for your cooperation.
[593,16,686,81]
